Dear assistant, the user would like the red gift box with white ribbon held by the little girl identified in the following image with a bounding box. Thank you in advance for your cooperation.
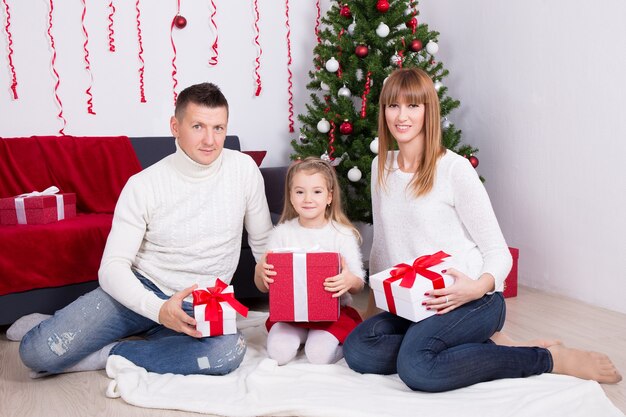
[267,252,341,322]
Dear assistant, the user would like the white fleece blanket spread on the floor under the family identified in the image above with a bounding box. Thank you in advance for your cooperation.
[106,312,624,417]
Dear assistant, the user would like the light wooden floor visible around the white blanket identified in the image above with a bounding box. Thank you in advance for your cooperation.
[0,287,626,417]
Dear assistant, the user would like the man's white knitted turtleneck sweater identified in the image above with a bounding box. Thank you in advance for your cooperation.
[99,144,272,322]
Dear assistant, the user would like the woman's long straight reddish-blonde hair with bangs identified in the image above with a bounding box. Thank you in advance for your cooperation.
[378,68,445,197]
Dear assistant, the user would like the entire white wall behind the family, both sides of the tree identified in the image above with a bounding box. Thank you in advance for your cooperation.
[0,0,626,312]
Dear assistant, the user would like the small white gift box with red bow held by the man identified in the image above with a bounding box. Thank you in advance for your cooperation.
[191,278,248,337]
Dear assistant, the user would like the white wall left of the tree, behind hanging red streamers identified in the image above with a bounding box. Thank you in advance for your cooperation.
[0,0,322,166]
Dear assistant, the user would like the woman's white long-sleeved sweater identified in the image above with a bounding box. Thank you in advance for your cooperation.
[369,151,512,291]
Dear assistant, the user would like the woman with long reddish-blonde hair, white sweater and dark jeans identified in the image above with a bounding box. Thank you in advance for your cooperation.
[344,68,621,392]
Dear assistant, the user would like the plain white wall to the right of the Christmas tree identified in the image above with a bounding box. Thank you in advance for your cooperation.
[420,0,626,312]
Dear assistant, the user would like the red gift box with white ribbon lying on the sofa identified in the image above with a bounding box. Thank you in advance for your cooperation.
[0,187,76,225]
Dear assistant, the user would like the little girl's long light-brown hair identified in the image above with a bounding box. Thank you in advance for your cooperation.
[278,156,361,244]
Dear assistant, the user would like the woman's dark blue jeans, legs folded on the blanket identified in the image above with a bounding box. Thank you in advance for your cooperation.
[343,292,552,392]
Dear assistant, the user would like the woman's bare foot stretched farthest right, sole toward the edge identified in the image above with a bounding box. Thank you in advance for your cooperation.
[548,345,622,384]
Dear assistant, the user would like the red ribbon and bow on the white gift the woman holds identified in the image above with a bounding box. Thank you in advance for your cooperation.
[383,251,450,314]
